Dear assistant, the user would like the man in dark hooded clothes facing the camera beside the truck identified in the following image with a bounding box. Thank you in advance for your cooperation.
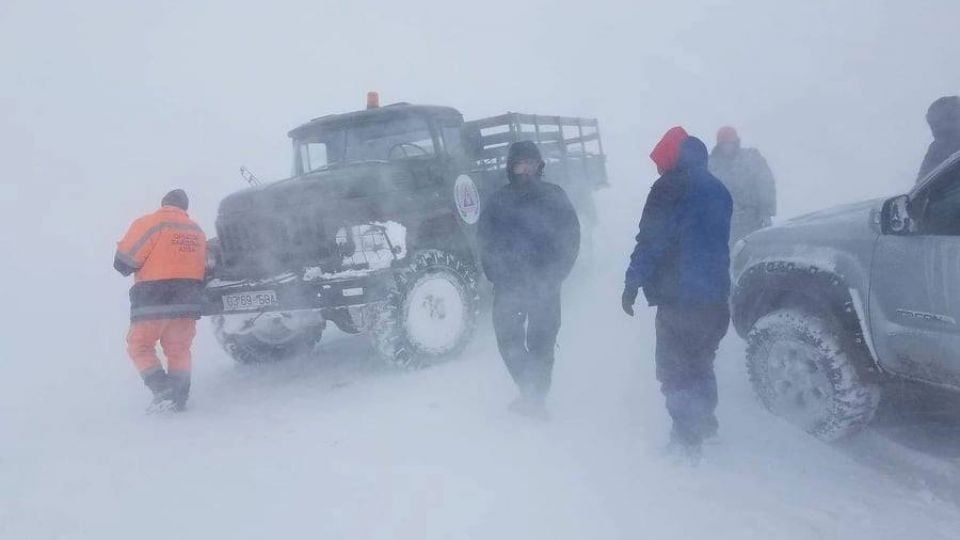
[477,141,580,416]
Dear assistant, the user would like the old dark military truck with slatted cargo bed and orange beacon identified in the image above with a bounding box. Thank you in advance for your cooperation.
[204,96,607,365]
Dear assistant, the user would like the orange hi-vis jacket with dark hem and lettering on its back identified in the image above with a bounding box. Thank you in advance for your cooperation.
[113,206,207,321]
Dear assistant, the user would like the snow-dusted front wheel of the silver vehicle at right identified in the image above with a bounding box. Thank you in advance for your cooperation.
[747,309,880,441]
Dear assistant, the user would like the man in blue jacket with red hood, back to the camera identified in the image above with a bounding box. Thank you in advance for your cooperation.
[622,130,733,455]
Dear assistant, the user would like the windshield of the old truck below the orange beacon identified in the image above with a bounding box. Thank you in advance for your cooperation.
[295,116,436,174]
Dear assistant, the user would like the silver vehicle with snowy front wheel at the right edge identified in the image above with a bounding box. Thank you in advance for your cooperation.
[731,153,960,440]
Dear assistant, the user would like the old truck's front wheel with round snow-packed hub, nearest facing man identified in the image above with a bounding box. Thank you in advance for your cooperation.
[369,249,480,367]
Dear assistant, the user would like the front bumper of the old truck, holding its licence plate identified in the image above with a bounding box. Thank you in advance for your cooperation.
[203,270,393,315]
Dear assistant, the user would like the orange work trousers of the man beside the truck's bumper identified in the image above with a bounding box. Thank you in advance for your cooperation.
[127,319,197,375]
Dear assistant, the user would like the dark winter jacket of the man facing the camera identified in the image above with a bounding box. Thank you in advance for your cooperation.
[477,144,580,291]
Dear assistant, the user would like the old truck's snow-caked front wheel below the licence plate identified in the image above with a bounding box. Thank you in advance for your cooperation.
[213,313,323,364]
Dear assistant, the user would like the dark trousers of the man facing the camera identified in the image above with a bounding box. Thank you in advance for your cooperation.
[493,287,561,400]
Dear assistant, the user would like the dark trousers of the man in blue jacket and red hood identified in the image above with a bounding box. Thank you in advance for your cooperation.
[656,304,730,444]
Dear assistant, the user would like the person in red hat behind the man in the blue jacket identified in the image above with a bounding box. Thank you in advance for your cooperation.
[710,126,777,246]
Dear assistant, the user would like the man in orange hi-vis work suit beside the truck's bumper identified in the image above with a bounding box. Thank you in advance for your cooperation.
[113,189,207,410]
